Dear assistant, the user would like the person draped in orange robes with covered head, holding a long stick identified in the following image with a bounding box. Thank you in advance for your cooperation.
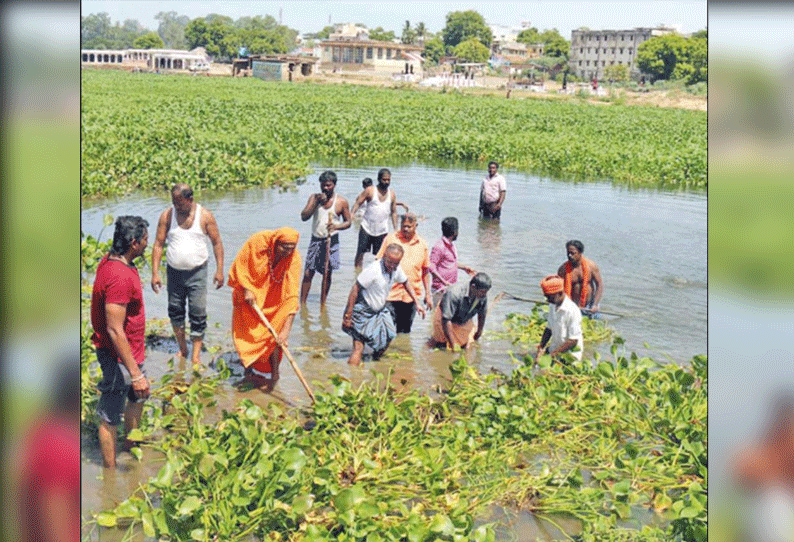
[229,228,301,391]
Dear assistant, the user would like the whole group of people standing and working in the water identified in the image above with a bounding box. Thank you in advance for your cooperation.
[91,162,603,467]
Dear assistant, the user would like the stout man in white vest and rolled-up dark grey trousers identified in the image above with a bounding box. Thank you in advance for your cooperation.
[152,183,224,365]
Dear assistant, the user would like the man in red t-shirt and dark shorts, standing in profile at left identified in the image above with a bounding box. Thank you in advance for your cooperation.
[91,216,149,468]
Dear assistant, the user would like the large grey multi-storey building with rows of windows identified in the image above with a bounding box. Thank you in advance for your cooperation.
[568,26,675,80]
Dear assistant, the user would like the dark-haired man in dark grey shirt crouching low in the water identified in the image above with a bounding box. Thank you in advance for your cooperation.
[431,273,491,351]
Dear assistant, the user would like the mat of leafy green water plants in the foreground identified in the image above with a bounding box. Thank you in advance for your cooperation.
[86,345,707,541]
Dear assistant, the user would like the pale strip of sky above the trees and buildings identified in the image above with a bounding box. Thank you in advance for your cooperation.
[81,0,707,40]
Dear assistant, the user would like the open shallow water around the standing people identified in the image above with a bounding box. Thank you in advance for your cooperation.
[82,164,707,537]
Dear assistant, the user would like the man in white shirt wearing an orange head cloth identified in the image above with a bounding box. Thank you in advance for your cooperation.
[535,275,582,360]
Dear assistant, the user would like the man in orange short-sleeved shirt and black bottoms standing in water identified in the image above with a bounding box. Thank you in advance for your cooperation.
[376,213,433,333]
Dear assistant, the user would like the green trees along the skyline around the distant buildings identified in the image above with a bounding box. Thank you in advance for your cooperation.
[81,10,708,84]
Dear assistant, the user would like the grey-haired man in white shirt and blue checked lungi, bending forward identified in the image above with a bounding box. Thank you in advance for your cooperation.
[342,243,425,365]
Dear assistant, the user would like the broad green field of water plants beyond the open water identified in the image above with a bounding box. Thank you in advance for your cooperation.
[81,70,706,196]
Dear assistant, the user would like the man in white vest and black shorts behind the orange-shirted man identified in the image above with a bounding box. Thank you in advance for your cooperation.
[350,168,397,270]
